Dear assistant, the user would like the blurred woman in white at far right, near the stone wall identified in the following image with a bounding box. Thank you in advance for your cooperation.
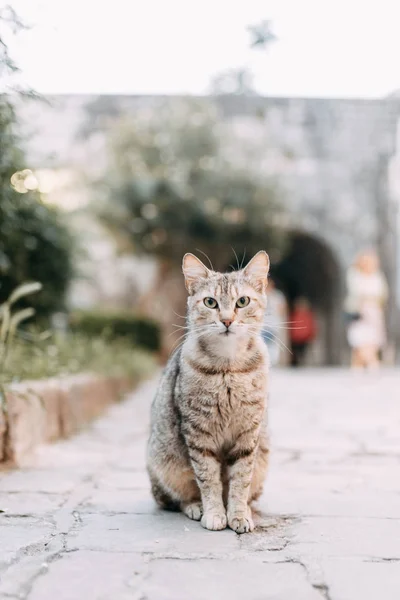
[345,250,388,369]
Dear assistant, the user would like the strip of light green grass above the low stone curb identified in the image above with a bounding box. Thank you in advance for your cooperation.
[3,333,156,383]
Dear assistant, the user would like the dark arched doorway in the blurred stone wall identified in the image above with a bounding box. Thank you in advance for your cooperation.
[271,231,343,365]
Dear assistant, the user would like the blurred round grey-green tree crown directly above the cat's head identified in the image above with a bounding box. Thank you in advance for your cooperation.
[91,99,284,268]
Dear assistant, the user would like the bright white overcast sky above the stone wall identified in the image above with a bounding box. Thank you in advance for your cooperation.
[0,0,400,98]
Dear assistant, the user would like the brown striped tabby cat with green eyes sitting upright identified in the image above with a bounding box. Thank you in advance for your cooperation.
[147,251,269,533]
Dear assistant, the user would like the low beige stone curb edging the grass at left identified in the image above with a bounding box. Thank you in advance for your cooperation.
[0,374,134,466]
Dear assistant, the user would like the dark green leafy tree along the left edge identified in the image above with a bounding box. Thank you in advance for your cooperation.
[0,7,72,314]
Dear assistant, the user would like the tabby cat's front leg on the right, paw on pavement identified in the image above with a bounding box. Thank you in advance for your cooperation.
[227,440,257,533]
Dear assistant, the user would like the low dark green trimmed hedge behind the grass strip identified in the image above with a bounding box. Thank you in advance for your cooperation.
[70,311,161,352]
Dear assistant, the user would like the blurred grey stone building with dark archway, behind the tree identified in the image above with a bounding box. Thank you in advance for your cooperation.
[16,95,400,363]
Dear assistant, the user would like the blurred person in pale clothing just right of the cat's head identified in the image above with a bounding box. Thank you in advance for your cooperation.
[263,277,287,366]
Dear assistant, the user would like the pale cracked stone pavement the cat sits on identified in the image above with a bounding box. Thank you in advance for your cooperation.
[0,370,400,600]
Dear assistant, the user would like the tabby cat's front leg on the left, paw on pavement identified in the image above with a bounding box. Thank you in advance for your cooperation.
[188,441,227,531]
